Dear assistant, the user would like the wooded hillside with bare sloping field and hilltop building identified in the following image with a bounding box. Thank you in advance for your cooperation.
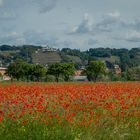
[0,45,140,71]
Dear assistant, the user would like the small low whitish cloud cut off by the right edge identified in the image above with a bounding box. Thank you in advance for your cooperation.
[125,31,140,42]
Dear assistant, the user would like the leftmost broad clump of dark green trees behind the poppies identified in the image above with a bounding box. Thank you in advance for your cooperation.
[6,60,46,81]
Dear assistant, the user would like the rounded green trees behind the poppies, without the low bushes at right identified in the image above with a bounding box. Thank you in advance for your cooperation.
[6,60,107,82]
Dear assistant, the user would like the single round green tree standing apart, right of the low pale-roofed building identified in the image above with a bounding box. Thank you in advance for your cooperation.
[85,61,106,82]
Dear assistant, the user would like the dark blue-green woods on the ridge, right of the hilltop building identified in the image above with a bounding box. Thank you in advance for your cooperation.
[61,48,140,71]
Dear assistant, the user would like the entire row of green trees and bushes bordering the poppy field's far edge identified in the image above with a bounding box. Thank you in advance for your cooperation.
[6,60,140,82]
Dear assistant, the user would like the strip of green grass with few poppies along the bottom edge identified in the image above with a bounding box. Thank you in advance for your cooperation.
[0,120,140,140]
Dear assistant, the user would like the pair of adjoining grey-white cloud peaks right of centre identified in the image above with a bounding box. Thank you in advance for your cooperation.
[70,11,122,34]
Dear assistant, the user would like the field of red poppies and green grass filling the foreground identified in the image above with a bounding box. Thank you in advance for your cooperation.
[0,82,140,140]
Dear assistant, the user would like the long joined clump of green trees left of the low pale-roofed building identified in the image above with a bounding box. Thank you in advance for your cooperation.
[6,60,75,82]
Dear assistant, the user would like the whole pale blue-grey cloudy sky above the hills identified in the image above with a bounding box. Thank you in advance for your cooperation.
[0,0,140,50]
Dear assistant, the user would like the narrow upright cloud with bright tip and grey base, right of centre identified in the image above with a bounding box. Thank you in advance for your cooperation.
[70,14,93,34]
